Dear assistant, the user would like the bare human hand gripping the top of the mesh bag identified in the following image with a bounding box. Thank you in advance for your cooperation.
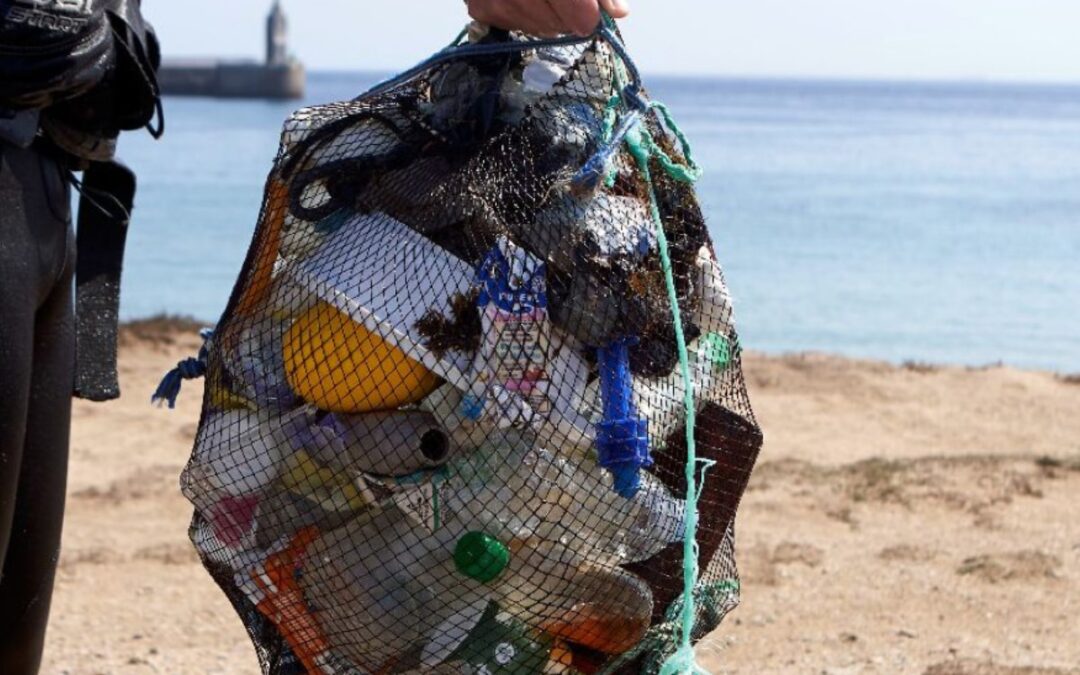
[467,0,630,36]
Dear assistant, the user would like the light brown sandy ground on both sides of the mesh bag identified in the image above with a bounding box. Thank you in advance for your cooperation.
[44,323,1080,675]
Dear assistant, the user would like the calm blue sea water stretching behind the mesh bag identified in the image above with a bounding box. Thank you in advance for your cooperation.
[121,73,1080,372]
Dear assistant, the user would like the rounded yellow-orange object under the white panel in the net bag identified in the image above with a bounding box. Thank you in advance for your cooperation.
[284,302,438,413]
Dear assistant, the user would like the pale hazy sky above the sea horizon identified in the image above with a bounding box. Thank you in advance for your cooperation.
[150,0,1080,82]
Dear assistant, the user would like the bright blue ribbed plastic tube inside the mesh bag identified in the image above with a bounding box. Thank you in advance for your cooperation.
[596,338,652,499]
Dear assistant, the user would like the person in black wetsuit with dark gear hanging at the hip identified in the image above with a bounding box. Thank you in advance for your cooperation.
[0,0,163,675]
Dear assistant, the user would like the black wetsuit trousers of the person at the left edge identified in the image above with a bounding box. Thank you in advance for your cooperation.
[0,119,75,675]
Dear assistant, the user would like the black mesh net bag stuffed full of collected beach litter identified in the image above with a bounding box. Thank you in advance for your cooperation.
[183,21,761,675]
